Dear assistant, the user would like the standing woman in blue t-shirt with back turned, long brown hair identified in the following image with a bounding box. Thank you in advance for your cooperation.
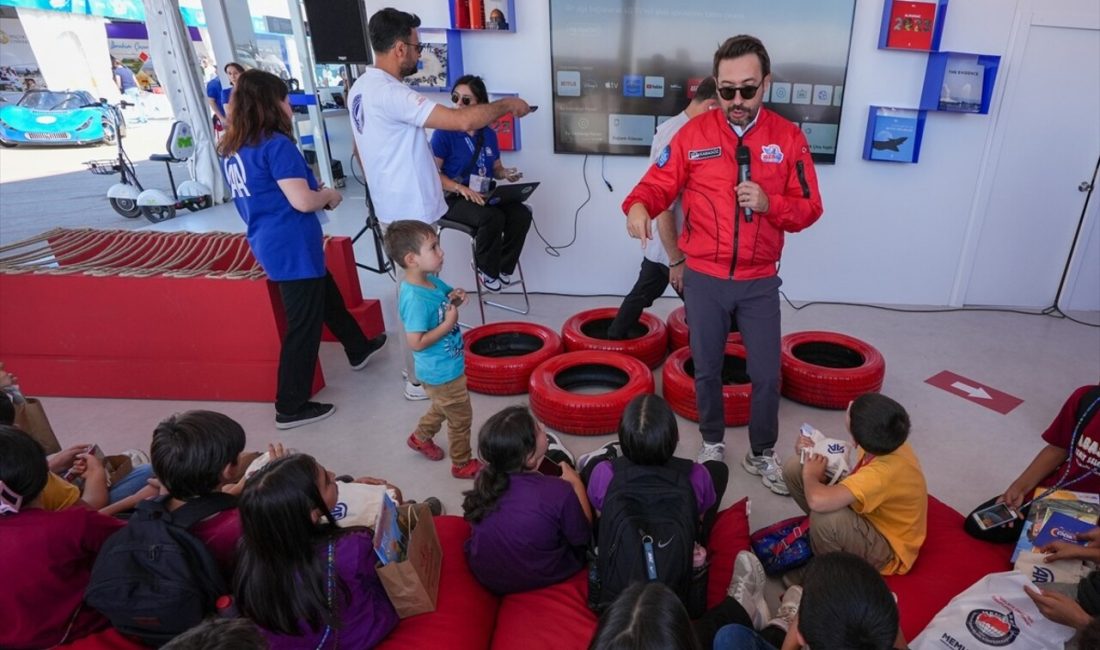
[218,70,386,429]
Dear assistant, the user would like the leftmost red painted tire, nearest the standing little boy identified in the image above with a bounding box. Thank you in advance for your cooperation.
[462,322,563,395]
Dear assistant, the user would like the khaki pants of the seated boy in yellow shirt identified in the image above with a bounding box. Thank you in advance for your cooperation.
[783,455,894,570]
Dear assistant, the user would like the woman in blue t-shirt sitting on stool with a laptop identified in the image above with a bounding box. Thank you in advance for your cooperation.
[431,75,531,291]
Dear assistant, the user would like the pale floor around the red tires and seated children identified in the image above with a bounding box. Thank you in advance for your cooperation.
[19,194,1100,538]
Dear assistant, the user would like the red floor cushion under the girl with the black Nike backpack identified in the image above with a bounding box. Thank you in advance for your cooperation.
[493,499,749,650]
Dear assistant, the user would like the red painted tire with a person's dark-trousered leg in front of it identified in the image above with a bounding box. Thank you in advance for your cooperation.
[561,307,668,368]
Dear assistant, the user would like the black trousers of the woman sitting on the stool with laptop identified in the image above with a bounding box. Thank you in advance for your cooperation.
[443,197,531,277]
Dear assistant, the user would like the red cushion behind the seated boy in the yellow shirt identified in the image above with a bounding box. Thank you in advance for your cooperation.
[886,496,1012,640]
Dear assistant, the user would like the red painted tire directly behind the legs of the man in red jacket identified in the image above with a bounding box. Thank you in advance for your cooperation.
[661,343,752,427]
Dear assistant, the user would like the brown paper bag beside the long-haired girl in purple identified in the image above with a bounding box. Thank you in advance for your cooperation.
[378,504,443,618]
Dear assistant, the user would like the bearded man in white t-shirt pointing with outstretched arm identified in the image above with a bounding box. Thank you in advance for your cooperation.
[348,8,531,399]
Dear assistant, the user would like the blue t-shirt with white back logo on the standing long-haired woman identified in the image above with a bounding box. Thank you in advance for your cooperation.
[222,133,326,282]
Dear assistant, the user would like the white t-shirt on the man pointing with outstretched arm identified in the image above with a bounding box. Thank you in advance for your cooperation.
[348,67,447,223]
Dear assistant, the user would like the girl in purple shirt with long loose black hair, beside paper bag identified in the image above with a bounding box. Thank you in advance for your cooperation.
[234,454,397,650]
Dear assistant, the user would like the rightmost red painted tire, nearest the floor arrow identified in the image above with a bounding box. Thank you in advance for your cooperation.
[780,332,887,409]
